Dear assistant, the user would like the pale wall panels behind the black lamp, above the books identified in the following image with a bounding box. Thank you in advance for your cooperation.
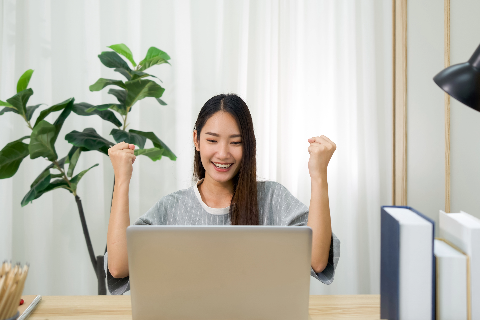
[407,0,480,228]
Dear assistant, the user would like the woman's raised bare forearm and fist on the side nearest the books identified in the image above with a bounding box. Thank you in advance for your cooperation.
[307,136,337,273]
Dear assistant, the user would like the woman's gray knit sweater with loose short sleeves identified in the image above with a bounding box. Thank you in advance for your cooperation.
[104,181,340,294]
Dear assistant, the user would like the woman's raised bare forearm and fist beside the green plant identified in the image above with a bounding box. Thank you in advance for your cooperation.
[107,142,136,278]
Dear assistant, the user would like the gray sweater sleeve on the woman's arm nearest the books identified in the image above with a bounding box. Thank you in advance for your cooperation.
[272,182,340,285]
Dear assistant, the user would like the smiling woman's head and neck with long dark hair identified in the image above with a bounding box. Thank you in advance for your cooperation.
[193,94,259,225]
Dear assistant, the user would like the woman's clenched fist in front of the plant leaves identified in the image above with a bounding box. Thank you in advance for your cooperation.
[108,142,137,183]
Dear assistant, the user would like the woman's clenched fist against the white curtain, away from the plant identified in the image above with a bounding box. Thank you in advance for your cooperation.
[308,136,337,179]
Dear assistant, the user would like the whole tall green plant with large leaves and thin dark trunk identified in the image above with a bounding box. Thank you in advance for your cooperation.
[0,44,176,294]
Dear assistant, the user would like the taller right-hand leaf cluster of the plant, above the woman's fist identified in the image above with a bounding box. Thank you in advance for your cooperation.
[76,43,177,161]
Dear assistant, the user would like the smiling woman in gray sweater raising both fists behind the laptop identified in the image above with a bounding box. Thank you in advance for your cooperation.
[105,94,340,294]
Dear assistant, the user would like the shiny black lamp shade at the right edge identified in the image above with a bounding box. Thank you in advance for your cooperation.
[433,45,480,111]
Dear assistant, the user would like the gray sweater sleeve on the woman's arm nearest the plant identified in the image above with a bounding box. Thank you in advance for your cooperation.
[103,197,165,295]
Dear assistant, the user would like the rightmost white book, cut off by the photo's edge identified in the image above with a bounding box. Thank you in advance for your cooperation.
[439,210,480,320]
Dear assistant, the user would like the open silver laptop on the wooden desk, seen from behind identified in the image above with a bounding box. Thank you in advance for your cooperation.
[127,226,312,320]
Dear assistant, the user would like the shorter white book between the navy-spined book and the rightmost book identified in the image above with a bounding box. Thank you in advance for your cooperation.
[433,239,467,320]
